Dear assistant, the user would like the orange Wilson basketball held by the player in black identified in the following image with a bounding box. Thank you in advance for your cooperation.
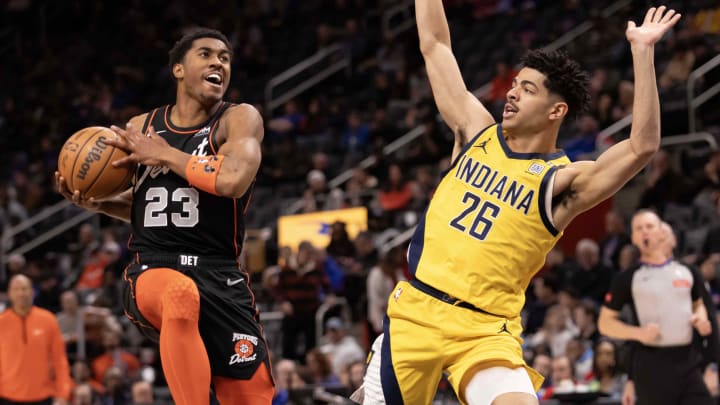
[58,127,135,199]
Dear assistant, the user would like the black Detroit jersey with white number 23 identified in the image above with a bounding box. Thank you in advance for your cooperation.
[129,103,252,259]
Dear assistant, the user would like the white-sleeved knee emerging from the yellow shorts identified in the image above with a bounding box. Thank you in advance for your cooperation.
[463,367,538,405]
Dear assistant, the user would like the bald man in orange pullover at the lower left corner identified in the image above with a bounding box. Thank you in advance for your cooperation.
[0,275,72,405]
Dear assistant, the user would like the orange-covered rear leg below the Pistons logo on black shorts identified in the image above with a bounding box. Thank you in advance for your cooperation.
[212,363,274,405]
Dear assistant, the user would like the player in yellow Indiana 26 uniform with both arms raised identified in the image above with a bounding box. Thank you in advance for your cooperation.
[380,0,680,405]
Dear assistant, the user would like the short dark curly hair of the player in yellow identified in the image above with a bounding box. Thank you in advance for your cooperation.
[522,49,590,119]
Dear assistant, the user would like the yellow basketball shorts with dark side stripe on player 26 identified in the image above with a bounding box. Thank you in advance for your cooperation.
[380,282,543,405]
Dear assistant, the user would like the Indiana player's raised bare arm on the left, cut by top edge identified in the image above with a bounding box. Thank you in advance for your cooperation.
[415,0,495,160]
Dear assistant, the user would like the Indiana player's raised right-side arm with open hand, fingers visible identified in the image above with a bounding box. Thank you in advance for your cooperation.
[553,6,680,229]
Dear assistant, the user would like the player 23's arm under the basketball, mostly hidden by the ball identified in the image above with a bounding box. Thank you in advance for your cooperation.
[55,113,147,223]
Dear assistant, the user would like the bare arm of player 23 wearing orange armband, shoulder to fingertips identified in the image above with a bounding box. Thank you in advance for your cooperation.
[108,104,264,198]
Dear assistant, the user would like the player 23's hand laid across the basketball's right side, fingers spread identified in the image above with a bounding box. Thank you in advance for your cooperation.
[105,122,171,167]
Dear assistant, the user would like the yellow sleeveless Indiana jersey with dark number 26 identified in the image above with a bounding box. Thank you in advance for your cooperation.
[408,124,570,318]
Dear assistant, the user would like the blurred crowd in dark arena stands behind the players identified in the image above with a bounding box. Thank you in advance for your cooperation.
[0,0,720,405]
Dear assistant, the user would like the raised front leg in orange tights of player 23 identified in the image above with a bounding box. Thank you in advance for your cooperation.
[135,268,210,405]
